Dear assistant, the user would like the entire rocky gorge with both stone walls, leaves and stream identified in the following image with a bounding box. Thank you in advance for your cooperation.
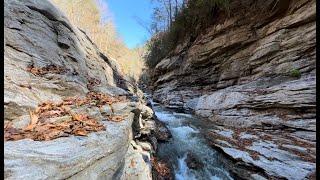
[4,0,316,180]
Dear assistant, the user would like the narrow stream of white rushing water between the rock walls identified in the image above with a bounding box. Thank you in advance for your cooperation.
[151,102,233,180]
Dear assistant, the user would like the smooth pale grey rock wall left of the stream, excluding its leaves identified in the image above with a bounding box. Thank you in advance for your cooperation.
[4,0,153,179]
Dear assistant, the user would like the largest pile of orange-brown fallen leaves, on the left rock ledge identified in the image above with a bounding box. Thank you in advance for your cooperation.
[4,92,125,141]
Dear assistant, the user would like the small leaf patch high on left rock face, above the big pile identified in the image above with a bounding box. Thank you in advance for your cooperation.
[27,64,66,76]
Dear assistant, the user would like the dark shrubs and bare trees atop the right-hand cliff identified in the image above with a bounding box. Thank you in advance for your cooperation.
[145,0,230,68]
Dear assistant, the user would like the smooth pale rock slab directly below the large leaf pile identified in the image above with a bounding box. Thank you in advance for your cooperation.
[4,114,133,179]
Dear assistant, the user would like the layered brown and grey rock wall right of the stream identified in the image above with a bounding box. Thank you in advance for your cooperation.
[152,0,316,179]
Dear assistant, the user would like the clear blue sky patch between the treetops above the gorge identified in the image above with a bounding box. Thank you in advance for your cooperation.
[103,0,153,48]
